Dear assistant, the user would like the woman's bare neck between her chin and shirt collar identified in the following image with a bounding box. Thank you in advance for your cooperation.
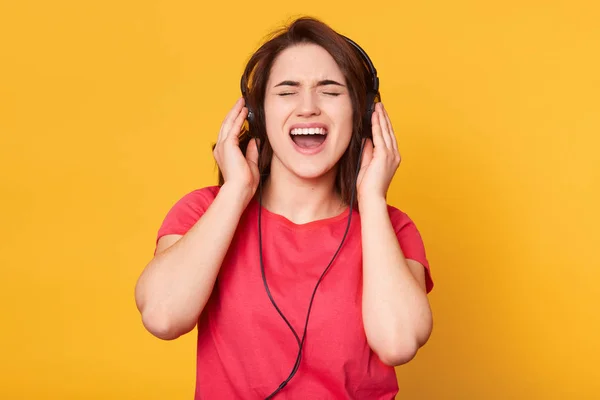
[262,158,346,224]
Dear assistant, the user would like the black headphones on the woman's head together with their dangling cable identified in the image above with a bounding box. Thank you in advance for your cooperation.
[240,35,381,400]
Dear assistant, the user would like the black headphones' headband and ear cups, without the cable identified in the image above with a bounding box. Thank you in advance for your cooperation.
[240,35,381,141]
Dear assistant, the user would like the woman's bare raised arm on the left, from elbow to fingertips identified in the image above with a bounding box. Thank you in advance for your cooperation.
[135,98,259,340]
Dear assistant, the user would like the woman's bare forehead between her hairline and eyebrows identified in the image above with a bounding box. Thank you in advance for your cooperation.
[269,43,344,82]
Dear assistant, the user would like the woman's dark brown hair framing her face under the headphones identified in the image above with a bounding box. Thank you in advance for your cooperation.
[219,17,372,206]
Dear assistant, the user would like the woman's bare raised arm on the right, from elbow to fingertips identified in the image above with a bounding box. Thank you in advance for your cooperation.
[358,103,432,365]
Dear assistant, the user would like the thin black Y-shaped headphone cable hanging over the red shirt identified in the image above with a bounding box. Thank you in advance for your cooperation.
[258,141,366,400]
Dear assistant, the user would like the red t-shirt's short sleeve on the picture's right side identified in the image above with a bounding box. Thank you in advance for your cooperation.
[388,206,433,293]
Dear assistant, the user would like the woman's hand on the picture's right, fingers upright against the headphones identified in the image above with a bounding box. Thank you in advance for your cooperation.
[357,103,401,204]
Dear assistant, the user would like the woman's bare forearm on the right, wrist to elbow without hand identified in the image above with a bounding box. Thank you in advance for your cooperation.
[359,198,432,365]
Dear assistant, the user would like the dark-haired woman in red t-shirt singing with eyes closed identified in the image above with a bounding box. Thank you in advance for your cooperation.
[136,14,433,400]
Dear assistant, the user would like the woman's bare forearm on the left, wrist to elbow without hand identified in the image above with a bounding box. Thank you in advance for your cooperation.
[136,186,248,339]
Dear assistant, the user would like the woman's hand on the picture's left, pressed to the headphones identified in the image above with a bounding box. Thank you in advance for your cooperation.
[213,97,260,200]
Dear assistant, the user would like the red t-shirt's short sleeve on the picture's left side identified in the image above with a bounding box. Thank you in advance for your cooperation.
[156,186,219,248]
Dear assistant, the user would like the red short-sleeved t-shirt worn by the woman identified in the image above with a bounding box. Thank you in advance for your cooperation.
[157,186,433,400]
